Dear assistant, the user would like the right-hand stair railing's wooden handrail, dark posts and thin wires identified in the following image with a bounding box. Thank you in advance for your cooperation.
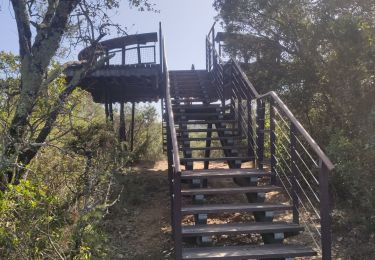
[206,22,334,259]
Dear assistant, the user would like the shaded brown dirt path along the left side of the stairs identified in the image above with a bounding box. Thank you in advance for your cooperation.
[103,162,172,259]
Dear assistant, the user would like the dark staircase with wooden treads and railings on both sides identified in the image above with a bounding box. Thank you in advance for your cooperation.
[162,23,333,259]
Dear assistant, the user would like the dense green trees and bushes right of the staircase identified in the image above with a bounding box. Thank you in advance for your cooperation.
[214,0,375,231]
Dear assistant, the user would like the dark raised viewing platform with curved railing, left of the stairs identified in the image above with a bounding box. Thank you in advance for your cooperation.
[68,32,162,105]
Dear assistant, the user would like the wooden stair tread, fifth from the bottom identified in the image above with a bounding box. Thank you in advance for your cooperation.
[181,169,271,179]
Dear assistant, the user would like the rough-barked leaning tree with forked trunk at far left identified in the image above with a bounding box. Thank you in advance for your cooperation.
[0,0,152,188]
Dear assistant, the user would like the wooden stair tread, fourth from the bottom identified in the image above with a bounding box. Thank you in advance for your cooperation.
[181,185,282,196]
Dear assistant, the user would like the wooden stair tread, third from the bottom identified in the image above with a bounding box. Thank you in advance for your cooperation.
[181,203,293,215]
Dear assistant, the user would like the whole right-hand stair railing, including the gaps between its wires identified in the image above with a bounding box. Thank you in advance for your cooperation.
[206,23,334,260]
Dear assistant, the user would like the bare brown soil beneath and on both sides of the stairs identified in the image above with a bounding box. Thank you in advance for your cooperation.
[103,161,375,260]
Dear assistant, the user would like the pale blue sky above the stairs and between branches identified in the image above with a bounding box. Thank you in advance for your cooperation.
[0,0,216,69]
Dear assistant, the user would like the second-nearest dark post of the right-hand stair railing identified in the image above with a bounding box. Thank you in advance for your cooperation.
[290,123,299,224]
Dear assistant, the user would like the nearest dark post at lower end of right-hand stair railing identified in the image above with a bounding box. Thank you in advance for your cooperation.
[319,161,332,260]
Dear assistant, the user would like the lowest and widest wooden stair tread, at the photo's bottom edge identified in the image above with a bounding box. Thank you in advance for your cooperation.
[182,244,316,260]
